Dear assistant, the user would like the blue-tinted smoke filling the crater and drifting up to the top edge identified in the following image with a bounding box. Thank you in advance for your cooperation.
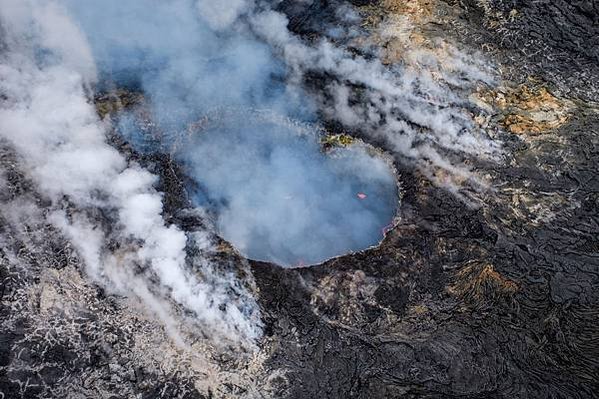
[62,1,398,266]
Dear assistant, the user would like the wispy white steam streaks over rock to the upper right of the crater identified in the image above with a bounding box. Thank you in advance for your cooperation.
[246,6,499,194]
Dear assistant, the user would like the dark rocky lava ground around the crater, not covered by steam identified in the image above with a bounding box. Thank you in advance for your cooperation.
[0,0,599,399]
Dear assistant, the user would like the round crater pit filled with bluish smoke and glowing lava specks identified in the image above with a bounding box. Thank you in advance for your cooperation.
[182,110,398,266]
